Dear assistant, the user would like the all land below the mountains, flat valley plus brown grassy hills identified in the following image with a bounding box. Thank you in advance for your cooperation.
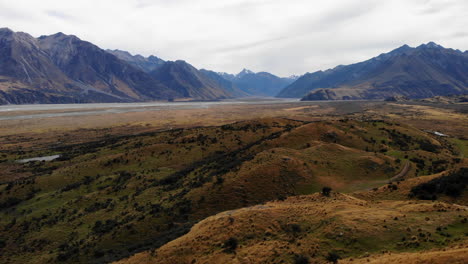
[0,101,468,264]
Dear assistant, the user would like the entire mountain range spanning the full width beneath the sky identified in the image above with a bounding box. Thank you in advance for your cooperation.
[0,28,468,104]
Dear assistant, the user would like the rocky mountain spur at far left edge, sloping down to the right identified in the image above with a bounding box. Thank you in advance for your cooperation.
[0,28,85,104]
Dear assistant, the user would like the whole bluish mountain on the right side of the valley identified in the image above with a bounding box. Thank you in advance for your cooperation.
[278,42,468,100]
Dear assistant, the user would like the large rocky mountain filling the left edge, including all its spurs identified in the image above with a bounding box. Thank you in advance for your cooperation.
[0,28,177,104]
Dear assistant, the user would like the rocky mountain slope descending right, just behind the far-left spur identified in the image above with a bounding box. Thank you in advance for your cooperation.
[38,33,177,101]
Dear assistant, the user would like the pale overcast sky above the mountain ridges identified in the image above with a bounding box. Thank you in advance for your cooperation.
[0,0,468,76]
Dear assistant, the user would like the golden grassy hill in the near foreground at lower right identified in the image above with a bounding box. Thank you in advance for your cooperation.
[117,193,468,264]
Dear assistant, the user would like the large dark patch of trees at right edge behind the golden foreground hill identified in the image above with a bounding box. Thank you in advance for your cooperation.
[410,168,468,200]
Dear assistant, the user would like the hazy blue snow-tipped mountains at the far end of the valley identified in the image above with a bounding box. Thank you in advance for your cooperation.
[219,69,295,96]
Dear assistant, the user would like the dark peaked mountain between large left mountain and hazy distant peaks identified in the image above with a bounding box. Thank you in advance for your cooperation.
[149,60,233,100]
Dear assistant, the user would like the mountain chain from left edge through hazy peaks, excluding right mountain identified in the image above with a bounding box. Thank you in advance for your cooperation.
[0,28,290,104]
